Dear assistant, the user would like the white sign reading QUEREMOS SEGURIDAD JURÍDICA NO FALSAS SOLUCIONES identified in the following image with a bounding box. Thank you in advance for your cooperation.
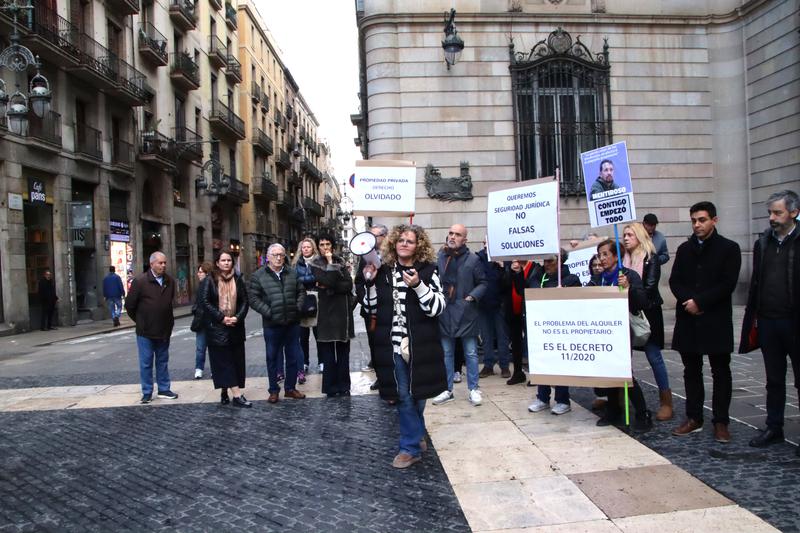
[486,178,559,260]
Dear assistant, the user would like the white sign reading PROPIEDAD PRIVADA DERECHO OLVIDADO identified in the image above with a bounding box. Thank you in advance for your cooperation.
[352,160,417,216]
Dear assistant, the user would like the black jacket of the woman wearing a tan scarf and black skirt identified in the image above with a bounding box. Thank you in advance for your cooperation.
[197,275,250,346]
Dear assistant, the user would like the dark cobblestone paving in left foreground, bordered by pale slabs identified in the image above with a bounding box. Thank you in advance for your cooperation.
[0,396,469,533]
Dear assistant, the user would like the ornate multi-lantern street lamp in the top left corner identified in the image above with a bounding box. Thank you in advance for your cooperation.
[0,0,53,131]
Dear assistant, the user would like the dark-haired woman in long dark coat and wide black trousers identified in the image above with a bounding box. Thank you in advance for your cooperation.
[310,235,353,398]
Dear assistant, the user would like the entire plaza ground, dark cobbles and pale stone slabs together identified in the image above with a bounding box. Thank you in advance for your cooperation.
[0,308,800,532]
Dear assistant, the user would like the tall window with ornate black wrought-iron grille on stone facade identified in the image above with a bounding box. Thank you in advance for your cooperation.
[510,28,611,196]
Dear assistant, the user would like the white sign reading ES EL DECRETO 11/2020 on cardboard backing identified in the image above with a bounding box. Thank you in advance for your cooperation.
[525,287,632,387]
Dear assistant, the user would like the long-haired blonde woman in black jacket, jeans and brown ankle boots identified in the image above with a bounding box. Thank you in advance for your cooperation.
[622,222,673,421]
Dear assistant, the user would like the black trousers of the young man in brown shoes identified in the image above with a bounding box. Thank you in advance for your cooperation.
[681,352,733,425]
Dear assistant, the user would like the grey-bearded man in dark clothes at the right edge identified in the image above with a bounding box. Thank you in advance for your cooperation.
[739,190,800,450]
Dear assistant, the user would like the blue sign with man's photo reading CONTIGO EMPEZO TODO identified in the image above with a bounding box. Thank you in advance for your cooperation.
[581,141,636,228]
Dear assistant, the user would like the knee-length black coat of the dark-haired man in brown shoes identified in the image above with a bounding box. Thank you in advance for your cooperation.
[669,230,742,354]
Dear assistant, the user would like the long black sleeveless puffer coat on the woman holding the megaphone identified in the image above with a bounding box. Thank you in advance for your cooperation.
[373,263,447,400]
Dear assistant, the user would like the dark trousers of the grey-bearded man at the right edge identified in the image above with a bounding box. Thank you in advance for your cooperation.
[758,318,800,429]
